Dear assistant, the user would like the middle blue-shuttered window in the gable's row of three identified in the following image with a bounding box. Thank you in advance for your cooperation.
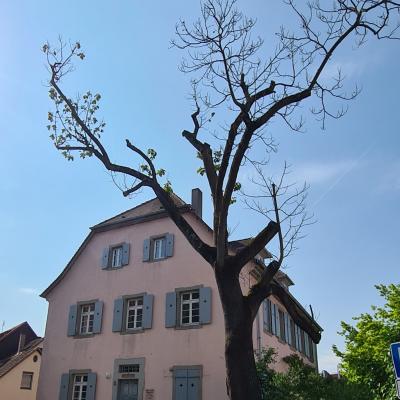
[112,293,154,333]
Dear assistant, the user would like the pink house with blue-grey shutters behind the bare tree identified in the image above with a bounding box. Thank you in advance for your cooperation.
[38,189,321,400]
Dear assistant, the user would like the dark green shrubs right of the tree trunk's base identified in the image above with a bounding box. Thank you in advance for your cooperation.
[257,348,373,400]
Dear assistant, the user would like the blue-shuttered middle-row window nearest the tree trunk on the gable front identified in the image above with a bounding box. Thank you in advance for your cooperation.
[165,287,212,329]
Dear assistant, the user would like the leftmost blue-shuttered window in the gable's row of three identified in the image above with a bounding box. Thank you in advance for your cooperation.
[67,300,103,337]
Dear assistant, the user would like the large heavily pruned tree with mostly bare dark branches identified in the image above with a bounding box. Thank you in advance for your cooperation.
[43,0,400,400]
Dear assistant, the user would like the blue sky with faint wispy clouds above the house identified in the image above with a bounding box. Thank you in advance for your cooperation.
[0,0,400,371]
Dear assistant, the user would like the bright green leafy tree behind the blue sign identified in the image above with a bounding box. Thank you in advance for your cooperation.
[333,284,400,400]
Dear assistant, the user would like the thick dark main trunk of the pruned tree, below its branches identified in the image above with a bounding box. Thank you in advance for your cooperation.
[216,272,262,400]
